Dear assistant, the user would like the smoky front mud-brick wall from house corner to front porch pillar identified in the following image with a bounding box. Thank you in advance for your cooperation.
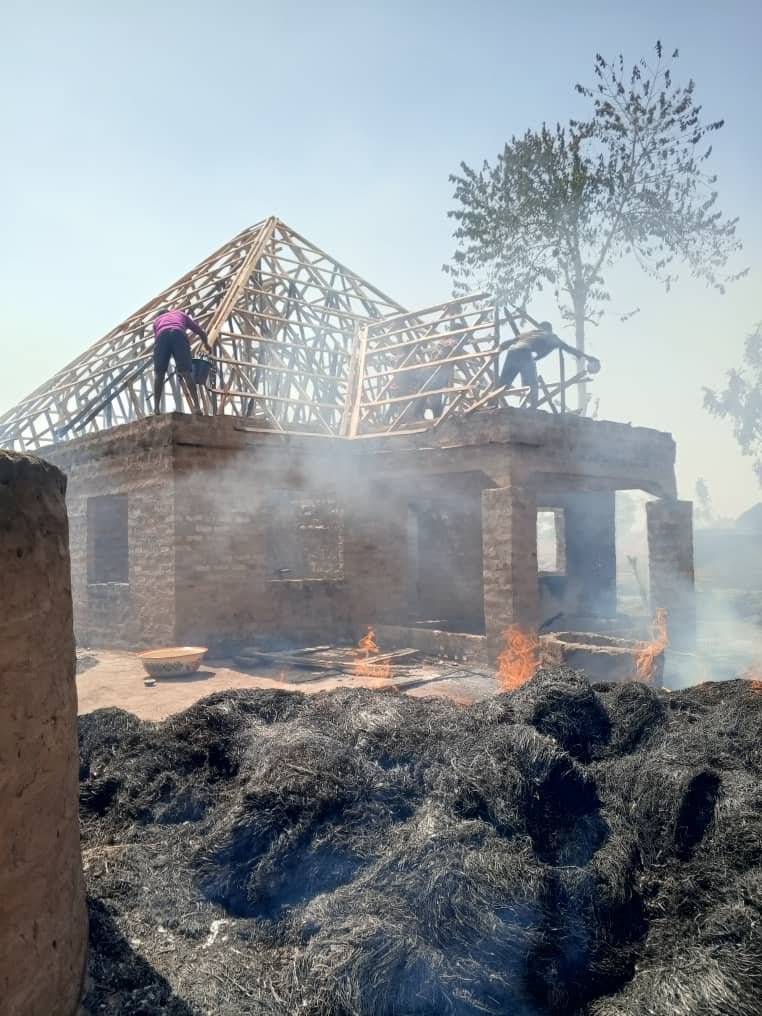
[170,420,491,644]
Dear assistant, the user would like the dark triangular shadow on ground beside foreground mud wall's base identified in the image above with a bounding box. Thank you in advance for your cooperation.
[79,897,197,1016]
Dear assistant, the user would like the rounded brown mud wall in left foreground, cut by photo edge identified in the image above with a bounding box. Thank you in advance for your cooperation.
[0,452,87,1016]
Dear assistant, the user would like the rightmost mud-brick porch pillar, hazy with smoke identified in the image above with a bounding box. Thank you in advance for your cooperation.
[645,500,696,648]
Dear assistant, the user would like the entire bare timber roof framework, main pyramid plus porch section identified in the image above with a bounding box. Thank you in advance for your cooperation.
[0,217,588,451]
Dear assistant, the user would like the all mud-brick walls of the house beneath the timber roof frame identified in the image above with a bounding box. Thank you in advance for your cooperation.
[37,409,675,648]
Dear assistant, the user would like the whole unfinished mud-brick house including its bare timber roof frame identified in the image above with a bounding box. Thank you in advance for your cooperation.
[0,218,693,659]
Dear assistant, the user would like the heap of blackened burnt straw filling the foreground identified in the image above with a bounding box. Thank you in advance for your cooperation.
[79,670,762,1016]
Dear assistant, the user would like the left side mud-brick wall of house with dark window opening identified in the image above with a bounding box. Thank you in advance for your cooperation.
[46,418,175,649]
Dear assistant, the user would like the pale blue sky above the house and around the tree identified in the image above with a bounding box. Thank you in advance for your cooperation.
[0,0,762,514]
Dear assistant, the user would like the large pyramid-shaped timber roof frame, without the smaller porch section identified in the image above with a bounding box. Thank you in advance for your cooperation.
[0,216,403,450]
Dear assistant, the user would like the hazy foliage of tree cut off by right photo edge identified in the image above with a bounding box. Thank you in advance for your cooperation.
[704,321,762,485]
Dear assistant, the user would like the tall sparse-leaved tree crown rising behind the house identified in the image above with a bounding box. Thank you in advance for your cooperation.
[445,43,744,404]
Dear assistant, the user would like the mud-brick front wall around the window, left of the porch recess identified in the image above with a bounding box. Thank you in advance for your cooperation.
[174,444,350,650]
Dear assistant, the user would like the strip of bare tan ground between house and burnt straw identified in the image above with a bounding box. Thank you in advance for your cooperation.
[77,649,498,719]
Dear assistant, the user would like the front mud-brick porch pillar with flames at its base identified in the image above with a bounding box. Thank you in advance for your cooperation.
[482,487,539,656]
